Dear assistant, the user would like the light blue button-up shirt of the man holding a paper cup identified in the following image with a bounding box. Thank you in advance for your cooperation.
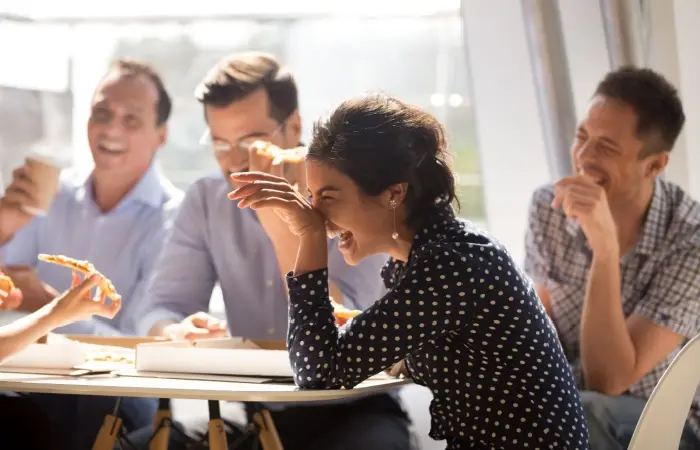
[0,165,183,335]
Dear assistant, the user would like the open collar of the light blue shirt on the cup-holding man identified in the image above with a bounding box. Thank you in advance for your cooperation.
[75,163,175,213]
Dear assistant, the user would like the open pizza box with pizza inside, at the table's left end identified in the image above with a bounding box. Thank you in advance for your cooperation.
[0,333,163,376]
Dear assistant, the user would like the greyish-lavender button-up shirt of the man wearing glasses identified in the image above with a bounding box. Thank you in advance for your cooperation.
[137,175,387,339]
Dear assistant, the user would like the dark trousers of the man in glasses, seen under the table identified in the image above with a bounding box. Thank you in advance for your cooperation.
[128,394,417,450]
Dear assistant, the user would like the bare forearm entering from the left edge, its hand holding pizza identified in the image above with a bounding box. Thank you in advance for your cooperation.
[0,305,60,361]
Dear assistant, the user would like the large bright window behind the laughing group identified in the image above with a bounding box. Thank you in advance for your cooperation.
[0,10,485,222]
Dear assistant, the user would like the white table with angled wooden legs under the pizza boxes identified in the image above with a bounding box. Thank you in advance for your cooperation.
[0,372,409,450]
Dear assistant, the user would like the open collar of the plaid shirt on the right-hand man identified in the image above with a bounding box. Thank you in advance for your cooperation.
[566,179,670,255]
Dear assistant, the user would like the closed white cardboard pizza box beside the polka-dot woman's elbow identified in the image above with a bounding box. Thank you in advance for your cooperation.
[136,337,293,377]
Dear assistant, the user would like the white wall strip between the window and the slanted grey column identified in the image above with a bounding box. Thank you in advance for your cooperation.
[462,0,550,262]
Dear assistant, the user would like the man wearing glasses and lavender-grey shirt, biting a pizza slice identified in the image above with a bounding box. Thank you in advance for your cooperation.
[131,53,411,450]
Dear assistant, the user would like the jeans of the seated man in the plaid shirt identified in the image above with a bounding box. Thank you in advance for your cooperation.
[581,391,700,450]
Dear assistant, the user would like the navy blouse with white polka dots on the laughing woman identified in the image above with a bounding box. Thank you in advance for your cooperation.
[288,209,588,450]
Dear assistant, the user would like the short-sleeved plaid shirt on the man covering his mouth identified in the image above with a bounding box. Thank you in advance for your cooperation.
[525,180,700,436]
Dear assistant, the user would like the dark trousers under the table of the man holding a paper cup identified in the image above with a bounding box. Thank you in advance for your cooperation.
[18,394,158,450]
